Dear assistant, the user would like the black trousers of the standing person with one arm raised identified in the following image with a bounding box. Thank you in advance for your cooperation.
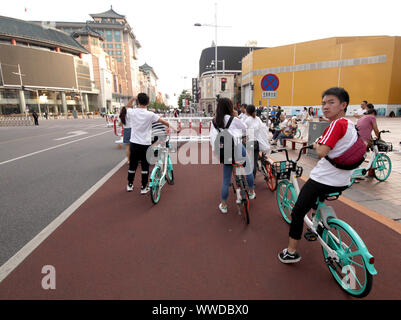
[128,142,150,188]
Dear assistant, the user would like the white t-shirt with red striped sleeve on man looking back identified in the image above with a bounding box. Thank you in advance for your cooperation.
[309,118,358,187]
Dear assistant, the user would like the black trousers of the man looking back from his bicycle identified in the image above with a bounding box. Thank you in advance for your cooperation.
[290,179,348,240]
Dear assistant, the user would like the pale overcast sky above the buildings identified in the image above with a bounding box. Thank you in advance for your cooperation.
[0,0,401,105]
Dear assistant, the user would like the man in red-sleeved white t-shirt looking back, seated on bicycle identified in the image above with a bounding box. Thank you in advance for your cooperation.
[278,87,358,263]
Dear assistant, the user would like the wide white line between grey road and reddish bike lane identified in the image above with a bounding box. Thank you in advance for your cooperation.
[0,159,127,283]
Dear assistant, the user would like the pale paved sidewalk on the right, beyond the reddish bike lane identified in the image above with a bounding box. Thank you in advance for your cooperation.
[271,117,401,223]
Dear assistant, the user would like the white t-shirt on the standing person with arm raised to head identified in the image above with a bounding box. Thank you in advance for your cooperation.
[127,108,160,146]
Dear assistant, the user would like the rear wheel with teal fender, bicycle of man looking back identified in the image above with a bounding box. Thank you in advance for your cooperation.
[322,219,373,298]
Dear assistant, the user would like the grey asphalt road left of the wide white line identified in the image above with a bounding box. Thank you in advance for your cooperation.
[0,119,125,265]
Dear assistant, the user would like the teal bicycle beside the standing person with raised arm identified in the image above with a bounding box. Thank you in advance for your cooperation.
[149,140,174,204]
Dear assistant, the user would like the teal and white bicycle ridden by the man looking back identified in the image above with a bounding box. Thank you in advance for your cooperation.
[271,145,377,298]
